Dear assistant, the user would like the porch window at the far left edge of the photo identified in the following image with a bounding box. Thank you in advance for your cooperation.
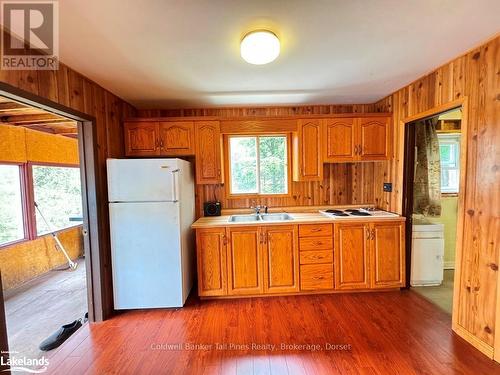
[0,164,25,245]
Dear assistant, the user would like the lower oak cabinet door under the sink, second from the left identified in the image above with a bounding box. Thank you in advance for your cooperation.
[227,226,264,295]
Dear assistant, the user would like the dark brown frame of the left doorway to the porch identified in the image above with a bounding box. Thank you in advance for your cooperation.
[0,82,109,334]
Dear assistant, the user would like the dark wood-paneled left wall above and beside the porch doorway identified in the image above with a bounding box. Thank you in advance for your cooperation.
[0,64,136,318]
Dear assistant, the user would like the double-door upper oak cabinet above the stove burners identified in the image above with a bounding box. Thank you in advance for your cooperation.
[323,117,391,163]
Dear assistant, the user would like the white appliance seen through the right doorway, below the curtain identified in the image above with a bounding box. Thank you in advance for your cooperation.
[410,220,444,286]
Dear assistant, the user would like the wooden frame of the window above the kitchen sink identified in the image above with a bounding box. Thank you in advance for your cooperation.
[223,132,292,199]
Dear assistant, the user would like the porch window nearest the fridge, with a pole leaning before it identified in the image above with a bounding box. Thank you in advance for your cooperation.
[32,165,82,236]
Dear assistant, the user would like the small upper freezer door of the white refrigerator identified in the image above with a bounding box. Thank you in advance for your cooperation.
[107,159,179,202]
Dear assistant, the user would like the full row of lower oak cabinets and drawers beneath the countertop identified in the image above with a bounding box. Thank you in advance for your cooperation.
[196,220,405,297]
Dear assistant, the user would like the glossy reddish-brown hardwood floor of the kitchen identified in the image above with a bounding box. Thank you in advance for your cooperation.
[44,291,500,375]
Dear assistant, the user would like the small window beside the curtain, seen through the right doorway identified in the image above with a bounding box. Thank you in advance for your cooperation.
[438,134,460,193]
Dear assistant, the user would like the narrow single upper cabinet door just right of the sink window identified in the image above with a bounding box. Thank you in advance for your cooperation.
[294,119,323,181]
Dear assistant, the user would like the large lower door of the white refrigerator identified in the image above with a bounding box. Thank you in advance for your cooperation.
[109,202,184,310]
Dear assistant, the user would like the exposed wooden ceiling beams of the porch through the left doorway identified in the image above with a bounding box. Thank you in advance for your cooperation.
[0,96,78,138]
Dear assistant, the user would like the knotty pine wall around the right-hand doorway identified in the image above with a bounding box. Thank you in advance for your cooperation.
[375,36,500,360]
